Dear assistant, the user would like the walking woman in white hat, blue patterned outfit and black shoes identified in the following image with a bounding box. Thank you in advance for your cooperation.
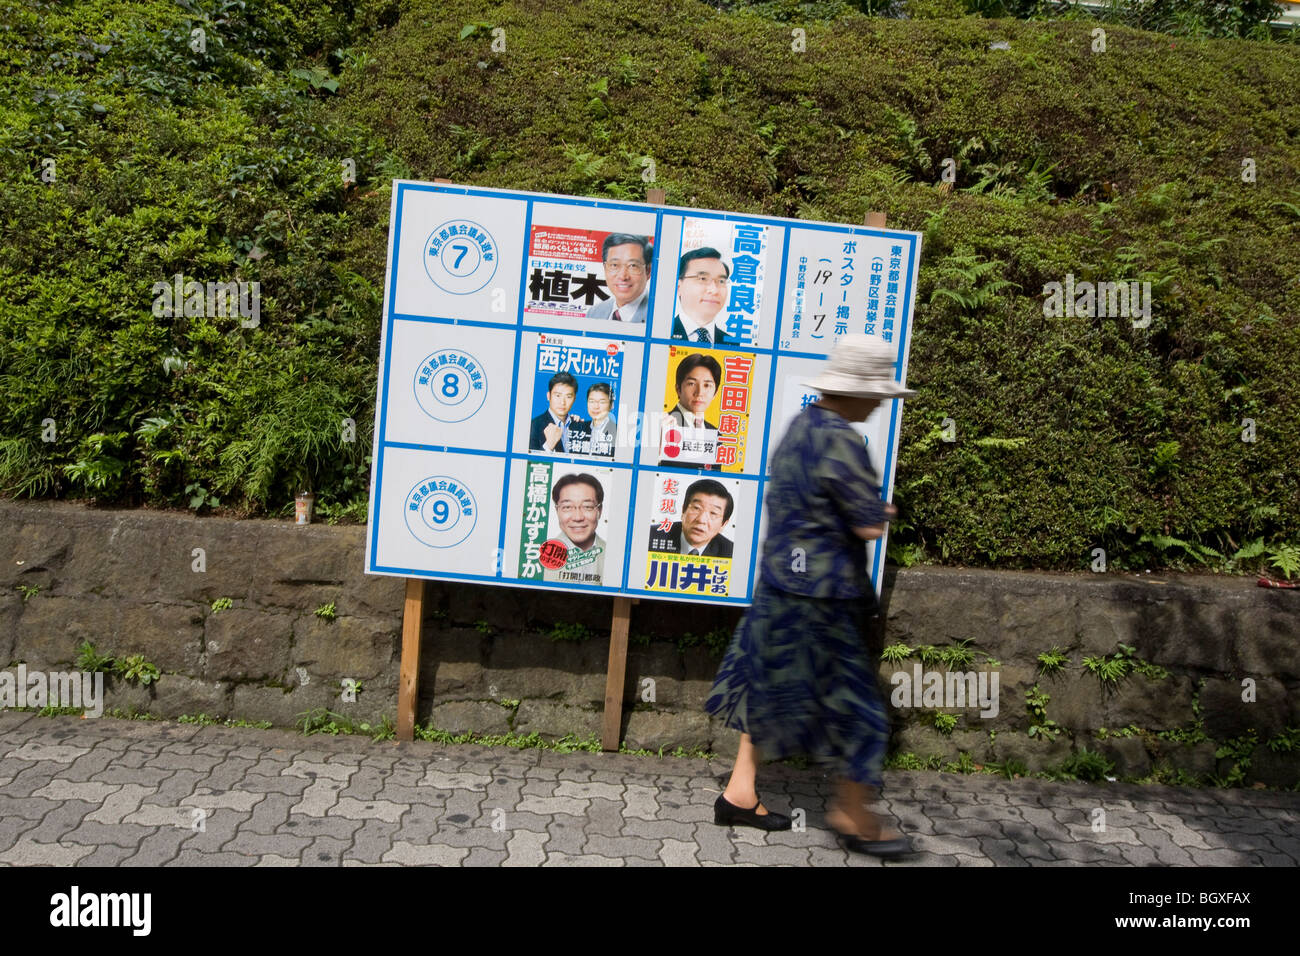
[705,336,917,857]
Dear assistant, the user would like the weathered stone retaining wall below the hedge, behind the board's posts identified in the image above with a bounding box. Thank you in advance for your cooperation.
[0,502,1300,786]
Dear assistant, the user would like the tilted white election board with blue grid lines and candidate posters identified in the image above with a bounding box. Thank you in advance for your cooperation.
[365,181,920,605]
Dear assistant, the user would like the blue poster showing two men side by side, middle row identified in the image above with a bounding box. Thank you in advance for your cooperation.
[528,333,625,458]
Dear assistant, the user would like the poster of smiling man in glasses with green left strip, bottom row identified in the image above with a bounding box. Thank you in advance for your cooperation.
[519,460,614,585]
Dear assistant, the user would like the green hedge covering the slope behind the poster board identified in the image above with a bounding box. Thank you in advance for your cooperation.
[0,0,1300,568]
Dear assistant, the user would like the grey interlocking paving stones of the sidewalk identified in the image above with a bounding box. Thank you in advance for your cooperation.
[0,713,1300,866]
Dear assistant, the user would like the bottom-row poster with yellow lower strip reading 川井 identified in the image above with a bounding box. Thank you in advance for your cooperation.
[645,473,751,597]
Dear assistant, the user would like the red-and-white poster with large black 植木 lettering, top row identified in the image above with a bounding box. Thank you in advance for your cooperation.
[524,224,654,323]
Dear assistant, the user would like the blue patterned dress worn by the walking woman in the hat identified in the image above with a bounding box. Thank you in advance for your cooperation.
[705,405,889,787]
